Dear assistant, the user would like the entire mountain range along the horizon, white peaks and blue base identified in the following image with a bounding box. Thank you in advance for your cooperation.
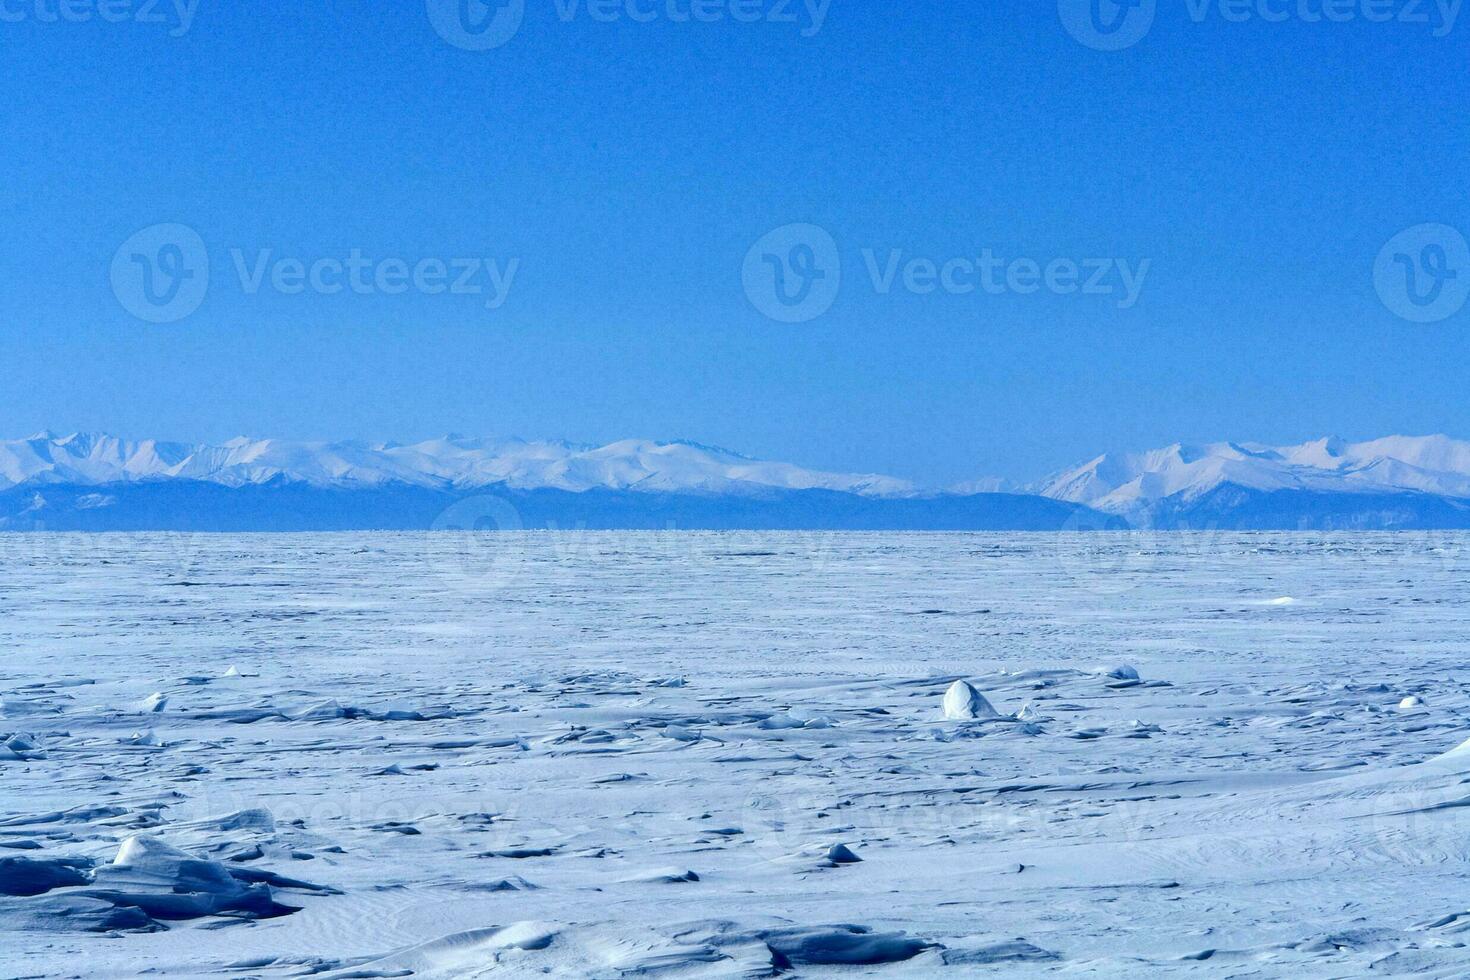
[0,433,1470,530]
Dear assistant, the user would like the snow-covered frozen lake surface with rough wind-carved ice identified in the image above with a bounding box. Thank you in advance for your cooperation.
[0,533,1470,977]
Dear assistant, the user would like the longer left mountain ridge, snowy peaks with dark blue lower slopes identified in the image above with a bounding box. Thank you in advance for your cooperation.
[0,433,1081,532]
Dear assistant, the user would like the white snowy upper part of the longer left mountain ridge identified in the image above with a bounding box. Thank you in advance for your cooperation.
[0,432,916,497]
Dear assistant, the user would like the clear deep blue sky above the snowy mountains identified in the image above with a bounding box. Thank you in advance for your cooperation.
[0,0,1470,483]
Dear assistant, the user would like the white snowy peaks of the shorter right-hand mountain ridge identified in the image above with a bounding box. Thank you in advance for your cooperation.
[1038,435,1470,514]
